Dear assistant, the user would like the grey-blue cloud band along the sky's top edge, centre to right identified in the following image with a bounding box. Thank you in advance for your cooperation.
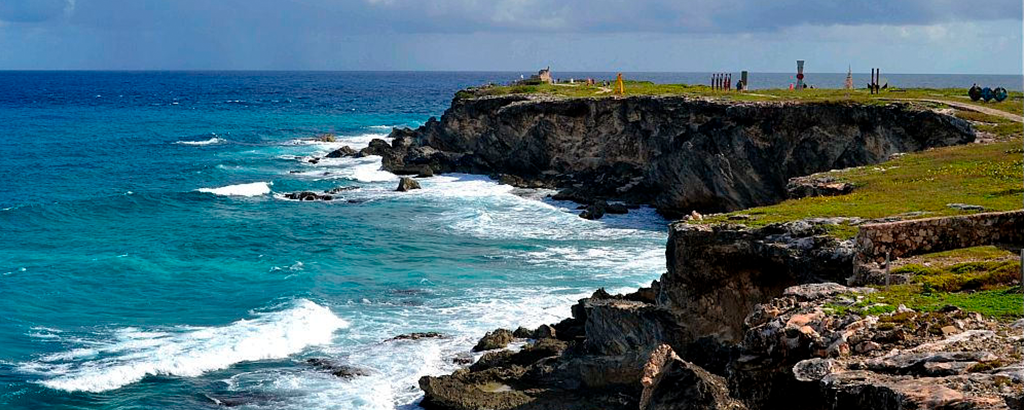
[360,0,1021,33]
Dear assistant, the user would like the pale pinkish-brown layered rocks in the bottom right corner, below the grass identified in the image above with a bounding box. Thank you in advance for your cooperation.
[741,285,1024,409]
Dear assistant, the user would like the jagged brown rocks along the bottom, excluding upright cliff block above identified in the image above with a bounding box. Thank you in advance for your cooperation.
[420,282,1024,410]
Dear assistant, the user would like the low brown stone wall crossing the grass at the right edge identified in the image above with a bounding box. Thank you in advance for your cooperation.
[851,210,1024,283]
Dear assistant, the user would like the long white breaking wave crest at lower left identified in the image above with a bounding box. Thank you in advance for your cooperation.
[19,299,348,392]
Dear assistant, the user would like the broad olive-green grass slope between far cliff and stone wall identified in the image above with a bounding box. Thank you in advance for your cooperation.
[695,138,1024,238]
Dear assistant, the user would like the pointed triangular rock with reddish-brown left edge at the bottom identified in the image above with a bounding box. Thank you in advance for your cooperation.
[640,344,746,410]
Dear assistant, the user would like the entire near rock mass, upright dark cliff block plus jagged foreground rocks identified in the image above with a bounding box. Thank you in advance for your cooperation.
[409,218,1024,410]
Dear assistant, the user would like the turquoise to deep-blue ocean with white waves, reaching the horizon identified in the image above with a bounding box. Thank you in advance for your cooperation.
[0,72,1021,410]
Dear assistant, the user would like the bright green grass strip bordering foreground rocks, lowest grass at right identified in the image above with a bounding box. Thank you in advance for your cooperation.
[825,284,1024,321]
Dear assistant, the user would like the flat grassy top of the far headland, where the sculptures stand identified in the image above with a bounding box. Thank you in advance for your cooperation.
[456,81,1024,115]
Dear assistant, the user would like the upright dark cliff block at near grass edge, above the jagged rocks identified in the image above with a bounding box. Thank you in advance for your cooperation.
[657,218,854,342]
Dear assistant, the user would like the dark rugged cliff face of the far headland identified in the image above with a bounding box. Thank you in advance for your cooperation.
[385,95,975,215]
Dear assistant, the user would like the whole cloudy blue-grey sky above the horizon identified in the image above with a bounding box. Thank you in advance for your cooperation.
[0,0,1024,74]
